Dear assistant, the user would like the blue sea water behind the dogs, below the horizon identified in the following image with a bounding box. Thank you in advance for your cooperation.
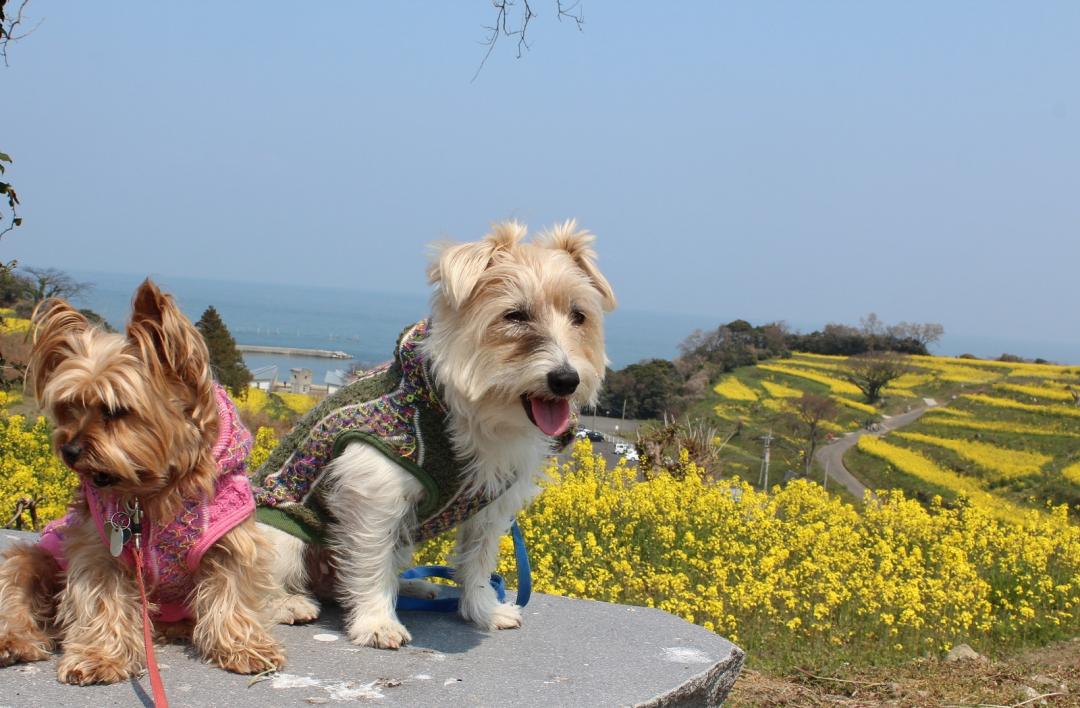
[72,272,719,383]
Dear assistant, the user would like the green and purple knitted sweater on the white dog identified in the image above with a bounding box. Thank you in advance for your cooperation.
[253,322,495,543]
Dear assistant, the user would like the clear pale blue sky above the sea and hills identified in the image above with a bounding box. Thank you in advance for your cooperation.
[0,0,1080,360]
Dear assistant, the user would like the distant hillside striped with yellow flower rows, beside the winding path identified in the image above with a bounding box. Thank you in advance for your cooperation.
[695,353,1080,516]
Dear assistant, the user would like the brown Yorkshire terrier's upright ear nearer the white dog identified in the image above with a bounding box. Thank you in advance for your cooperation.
[127,278,213,396]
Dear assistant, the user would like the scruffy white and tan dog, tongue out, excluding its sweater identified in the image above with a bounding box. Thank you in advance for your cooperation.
[261,221,616,649]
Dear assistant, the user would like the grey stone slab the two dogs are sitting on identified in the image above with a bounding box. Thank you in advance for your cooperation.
[0,531,744,708]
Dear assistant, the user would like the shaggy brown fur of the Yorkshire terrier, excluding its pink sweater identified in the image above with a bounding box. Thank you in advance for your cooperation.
[0,281,284,684]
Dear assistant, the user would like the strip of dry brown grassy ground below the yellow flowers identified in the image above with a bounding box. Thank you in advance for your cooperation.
[727,638,1080,707]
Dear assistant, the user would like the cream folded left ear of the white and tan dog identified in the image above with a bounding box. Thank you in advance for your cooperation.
[428,221,526,310]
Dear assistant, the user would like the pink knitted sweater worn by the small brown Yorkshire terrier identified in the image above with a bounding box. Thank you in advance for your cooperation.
[38,384,255,622]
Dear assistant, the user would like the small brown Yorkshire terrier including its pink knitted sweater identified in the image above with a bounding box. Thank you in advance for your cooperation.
[0,281,284,684]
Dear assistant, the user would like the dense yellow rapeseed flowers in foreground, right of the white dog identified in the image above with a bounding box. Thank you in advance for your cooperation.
[417,443,1080,665]
